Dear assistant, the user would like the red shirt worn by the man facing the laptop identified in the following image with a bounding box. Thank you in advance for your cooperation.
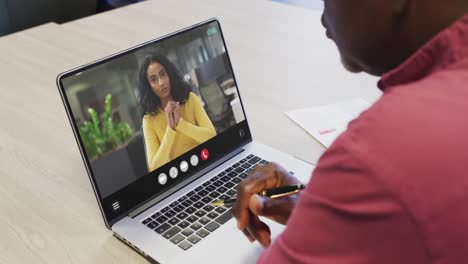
[259,16,468,264]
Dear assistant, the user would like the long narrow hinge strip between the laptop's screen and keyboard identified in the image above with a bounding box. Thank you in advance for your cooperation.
[128,147,244,218]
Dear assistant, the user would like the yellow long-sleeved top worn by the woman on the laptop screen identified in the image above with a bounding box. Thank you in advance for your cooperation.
[143,93,216,171]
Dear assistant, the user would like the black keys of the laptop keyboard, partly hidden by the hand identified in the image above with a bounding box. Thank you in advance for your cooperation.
[142,155,268,250]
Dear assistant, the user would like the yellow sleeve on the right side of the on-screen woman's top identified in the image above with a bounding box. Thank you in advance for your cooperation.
[176,94,216,144]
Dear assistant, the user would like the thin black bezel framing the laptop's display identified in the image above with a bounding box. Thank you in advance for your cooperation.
[56,18,252,229]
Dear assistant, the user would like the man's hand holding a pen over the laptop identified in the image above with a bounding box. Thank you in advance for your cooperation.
[232,163,300,247]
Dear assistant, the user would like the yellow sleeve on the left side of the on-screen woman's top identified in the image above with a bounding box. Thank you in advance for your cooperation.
[143,118,176,171]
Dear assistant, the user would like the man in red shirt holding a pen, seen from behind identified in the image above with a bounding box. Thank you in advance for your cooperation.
[233,0,468,264]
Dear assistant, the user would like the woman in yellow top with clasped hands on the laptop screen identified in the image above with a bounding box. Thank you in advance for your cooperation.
[138,54,216,171]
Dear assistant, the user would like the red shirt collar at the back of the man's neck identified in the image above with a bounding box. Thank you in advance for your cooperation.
[377,15,468,92]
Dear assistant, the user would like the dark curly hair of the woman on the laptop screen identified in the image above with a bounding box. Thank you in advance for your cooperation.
[138,53,192,115]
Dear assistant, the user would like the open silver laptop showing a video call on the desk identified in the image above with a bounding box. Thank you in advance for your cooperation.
[57,19,313,263]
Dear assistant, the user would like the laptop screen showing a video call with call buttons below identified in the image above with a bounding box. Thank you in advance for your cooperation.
[58,20,251,227]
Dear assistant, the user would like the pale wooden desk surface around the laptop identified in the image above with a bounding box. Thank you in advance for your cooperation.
[0,0,380,263]
